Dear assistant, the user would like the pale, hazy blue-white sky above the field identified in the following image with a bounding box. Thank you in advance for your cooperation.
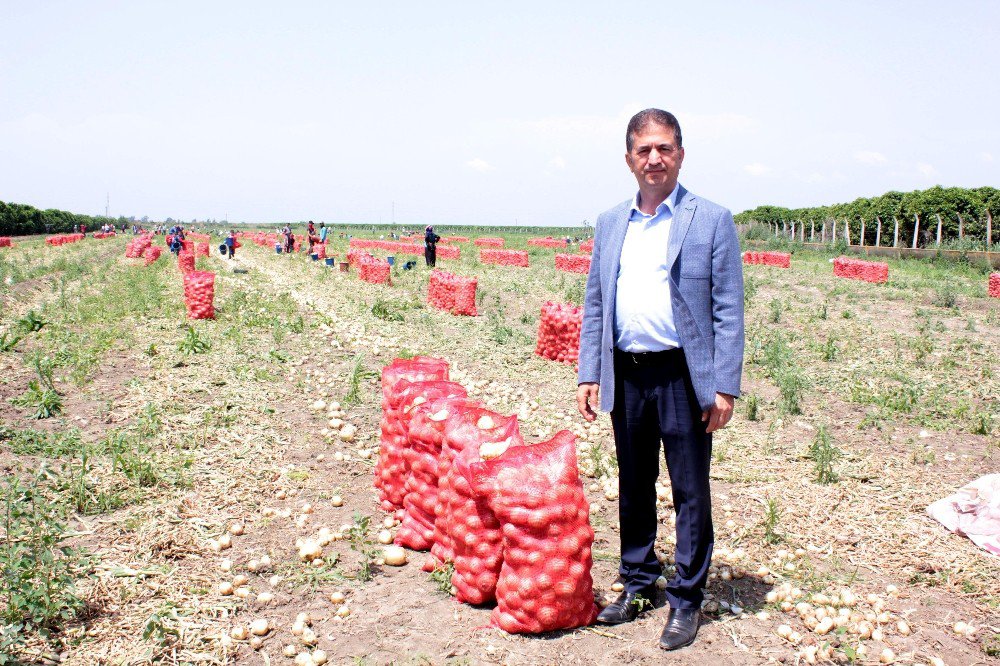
[0,0,1000,225]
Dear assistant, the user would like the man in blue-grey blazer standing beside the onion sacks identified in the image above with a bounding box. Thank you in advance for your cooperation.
[577,109,743,650]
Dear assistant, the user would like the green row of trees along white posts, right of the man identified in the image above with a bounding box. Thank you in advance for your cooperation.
[735,185,1000,245]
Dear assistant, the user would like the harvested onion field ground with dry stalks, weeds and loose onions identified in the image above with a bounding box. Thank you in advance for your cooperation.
[0,234,1000,665]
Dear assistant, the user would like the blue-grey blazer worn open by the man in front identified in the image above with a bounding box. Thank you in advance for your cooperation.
[578,186,743,411]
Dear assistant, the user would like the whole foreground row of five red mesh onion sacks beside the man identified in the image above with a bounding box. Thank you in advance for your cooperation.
[375,357,597,633]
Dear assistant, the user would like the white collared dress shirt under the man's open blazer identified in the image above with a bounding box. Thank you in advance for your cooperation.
[615,186,681,353]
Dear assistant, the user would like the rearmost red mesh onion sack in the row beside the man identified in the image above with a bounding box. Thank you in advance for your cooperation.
[374,356,448,511]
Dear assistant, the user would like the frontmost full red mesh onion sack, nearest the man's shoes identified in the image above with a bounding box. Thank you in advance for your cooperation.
[472,430,597,634]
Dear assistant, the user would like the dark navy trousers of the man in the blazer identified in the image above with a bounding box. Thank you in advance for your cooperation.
[611,349,715,608]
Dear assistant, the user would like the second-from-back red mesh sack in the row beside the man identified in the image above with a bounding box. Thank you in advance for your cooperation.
[377,380,466,519]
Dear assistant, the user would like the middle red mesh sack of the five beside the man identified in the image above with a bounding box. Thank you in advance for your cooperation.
[396,389,478,550]
